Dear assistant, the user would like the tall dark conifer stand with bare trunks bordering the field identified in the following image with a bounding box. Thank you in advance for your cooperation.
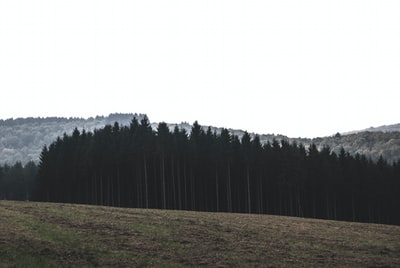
[30,117,400,224]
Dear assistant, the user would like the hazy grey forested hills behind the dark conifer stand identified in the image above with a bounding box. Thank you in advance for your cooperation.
[0,113,400,164]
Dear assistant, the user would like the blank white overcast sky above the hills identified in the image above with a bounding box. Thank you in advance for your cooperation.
[0,0,400,138]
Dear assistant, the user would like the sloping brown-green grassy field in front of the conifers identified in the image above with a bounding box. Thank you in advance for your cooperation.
[0,201,400,267]
